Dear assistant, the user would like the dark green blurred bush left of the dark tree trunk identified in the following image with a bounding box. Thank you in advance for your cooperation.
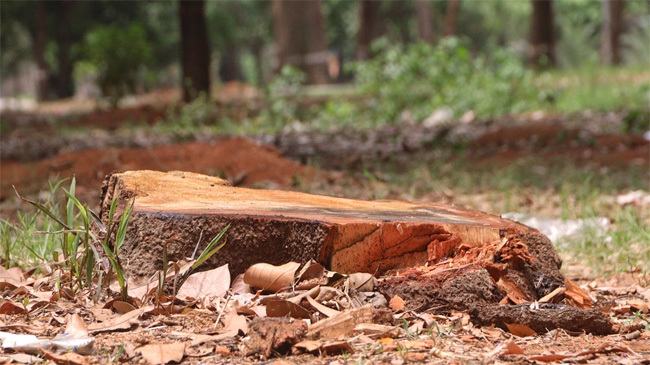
[84,23,151,105]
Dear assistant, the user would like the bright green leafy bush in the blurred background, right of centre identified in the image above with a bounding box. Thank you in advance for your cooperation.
[346,38,538,123]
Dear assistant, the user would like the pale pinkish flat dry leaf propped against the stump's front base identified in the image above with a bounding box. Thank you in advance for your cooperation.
[177,264,230,299]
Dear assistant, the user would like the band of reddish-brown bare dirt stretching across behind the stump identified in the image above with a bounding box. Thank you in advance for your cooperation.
[0,106,650,199]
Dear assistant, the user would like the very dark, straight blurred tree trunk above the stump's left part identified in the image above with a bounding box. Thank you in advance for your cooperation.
[178,0,210,102]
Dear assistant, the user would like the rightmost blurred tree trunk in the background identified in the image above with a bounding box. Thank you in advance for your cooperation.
[600,0,625,65]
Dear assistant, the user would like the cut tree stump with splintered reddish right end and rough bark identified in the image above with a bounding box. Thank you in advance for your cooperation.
[101,171,617,334]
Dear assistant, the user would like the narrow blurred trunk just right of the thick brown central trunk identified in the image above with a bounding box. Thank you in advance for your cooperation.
[357,0,386,60]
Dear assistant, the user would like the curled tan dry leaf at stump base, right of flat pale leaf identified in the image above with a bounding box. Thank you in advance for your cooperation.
[244,261,300,293]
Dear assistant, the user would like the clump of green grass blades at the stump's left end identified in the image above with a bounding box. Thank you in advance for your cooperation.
[9,178,132,300]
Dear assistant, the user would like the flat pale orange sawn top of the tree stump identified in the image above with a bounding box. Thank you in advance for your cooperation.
[116,170,528,229]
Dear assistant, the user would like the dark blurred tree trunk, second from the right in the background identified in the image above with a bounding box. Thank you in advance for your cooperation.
[528,0,555,66]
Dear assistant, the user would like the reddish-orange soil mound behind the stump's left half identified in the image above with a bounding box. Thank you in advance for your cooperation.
[0,138,317,197]
